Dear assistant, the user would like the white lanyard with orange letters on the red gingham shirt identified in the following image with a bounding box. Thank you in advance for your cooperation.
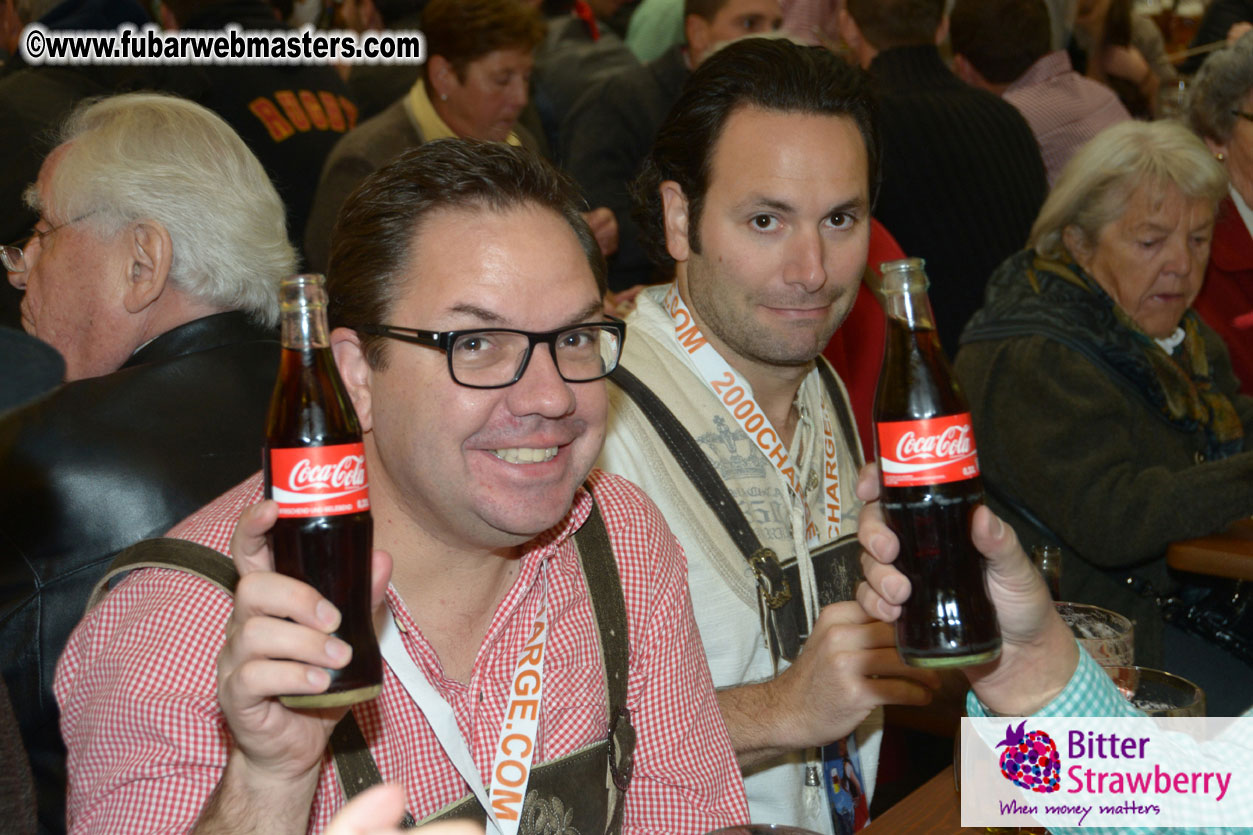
[378,582,548,835]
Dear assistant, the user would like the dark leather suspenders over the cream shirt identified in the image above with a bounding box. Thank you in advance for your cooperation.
[609,360,862,663]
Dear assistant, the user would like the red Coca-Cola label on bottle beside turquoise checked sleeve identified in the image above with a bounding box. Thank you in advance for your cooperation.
[875,412,979,486]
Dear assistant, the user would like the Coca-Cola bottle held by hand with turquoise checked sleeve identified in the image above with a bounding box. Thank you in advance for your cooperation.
[875,258,1001,667]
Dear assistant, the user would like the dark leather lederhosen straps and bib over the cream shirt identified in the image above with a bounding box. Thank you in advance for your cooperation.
[609,359,863,663]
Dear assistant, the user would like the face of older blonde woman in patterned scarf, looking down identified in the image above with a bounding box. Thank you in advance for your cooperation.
[1064,184,1214,339]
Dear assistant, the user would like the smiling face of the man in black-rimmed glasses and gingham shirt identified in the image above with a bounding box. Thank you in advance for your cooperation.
[353,201,608,549]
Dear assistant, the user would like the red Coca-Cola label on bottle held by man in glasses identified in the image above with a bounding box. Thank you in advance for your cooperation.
[269,444,370,519]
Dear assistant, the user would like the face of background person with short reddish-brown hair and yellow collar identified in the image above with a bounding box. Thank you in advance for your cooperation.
[435,49,534,142]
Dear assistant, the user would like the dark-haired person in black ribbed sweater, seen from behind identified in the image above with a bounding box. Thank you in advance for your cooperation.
[840,0,1048,356]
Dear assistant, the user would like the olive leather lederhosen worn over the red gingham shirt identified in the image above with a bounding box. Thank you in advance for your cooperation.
[88,496,635,835]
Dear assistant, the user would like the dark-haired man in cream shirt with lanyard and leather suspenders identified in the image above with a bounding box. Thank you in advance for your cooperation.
[601,38,937,832]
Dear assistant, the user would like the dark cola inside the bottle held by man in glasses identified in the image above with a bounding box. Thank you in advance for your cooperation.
[263,349,382,707]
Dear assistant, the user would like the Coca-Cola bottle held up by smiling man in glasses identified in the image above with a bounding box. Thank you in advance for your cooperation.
[264,276,382,707]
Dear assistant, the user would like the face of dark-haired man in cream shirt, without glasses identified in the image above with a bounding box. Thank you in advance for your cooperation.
[663,108,870,375]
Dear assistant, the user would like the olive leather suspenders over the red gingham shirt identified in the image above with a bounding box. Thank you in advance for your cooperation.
[88,493,635,832]
